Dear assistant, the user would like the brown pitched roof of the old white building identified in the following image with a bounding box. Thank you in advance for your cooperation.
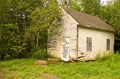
[63,8,115,32]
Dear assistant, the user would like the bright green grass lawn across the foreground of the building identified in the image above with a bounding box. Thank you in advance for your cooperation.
[0,54,120,79]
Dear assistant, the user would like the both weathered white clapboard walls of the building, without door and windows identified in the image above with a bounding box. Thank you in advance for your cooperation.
[48,9,114,61]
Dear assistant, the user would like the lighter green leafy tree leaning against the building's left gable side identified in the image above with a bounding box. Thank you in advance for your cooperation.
[26,0,60,49]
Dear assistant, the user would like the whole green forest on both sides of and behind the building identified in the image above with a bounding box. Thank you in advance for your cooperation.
[0,0,120,60]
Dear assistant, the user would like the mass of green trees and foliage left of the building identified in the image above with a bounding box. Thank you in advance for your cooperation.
[0,0,60,59]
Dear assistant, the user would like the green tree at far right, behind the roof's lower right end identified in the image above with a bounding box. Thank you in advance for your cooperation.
[99,0,120,50]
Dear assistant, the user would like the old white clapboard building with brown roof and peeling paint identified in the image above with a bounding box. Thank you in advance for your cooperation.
[48,8,115,61]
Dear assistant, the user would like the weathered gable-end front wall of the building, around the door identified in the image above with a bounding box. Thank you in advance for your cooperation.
[48,9,78,59]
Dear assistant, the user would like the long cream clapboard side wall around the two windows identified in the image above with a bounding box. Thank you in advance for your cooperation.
[78,27,114,60]
